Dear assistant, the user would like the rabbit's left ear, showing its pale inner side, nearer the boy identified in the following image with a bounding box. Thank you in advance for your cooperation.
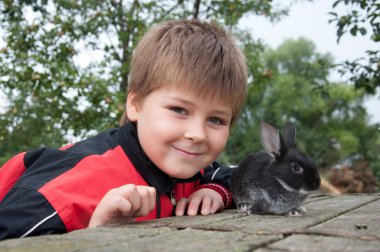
[261,122,281,158]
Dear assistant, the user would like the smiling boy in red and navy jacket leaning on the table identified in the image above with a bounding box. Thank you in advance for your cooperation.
[0,20,247,239]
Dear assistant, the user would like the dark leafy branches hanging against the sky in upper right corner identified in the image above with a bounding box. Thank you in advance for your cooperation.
[330,0,380,94]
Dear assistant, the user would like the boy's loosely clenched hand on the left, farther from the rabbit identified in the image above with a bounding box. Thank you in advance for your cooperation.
[88,184,156,227]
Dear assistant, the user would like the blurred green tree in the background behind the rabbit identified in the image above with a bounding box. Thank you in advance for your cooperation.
[222,38,380,173]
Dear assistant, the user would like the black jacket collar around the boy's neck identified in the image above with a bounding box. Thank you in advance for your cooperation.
[118,123,202,194]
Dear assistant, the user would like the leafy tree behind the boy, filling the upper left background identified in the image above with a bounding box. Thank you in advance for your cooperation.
[0,0,285,164]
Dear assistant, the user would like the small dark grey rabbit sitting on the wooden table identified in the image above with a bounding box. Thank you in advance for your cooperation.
[231,123,321,216]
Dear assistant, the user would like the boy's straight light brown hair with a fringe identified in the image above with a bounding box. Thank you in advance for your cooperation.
[120,20,247,125]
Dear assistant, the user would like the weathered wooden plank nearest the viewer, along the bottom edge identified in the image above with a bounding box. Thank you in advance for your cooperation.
[0,228,283,252]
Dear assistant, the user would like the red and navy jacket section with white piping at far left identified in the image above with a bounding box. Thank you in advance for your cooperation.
[0,151,66,240]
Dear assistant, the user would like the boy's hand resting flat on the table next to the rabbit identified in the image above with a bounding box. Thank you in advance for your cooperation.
[175,188,224,216]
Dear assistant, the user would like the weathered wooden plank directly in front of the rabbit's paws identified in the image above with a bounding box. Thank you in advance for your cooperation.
[123,194,380,232]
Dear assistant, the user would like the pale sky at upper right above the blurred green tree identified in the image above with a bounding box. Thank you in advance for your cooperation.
[240,0,380,123]
